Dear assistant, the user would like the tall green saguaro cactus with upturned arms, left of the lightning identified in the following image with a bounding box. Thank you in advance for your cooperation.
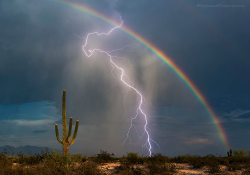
[55,90,79,156]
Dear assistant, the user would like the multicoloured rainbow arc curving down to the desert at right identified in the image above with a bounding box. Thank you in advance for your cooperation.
[50,0,230,150]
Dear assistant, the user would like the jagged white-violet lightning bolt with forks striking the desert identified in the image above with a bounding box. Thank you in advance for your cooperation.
[82,17,159,157]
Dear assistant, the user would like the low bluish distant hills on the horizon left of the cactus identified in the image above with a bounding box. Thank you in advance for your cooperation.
[0,145,62,155]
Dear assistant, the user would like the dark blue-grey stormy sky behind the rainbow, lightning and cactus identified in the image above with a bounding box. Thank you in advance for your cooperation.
[0,0,250,156]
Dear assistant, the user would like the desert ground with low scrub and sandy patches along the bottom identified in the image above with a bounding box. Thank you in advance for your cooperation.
[0,149,250,175]
